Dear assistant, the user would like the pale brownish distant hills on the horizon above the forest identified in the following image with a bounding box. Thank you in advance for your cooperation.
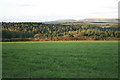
[45,18,118,25]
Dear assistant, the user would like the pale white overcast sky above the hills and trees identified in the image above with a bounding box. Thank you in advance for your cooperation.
[0,0,119,22]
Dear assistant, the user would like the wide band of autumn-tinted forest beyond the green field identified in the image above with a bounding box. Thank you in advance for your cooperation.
[2,22,120,41]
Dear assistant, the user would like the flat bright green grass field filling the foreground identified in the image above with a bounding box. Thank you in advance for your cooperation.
[2,41,118,78]
